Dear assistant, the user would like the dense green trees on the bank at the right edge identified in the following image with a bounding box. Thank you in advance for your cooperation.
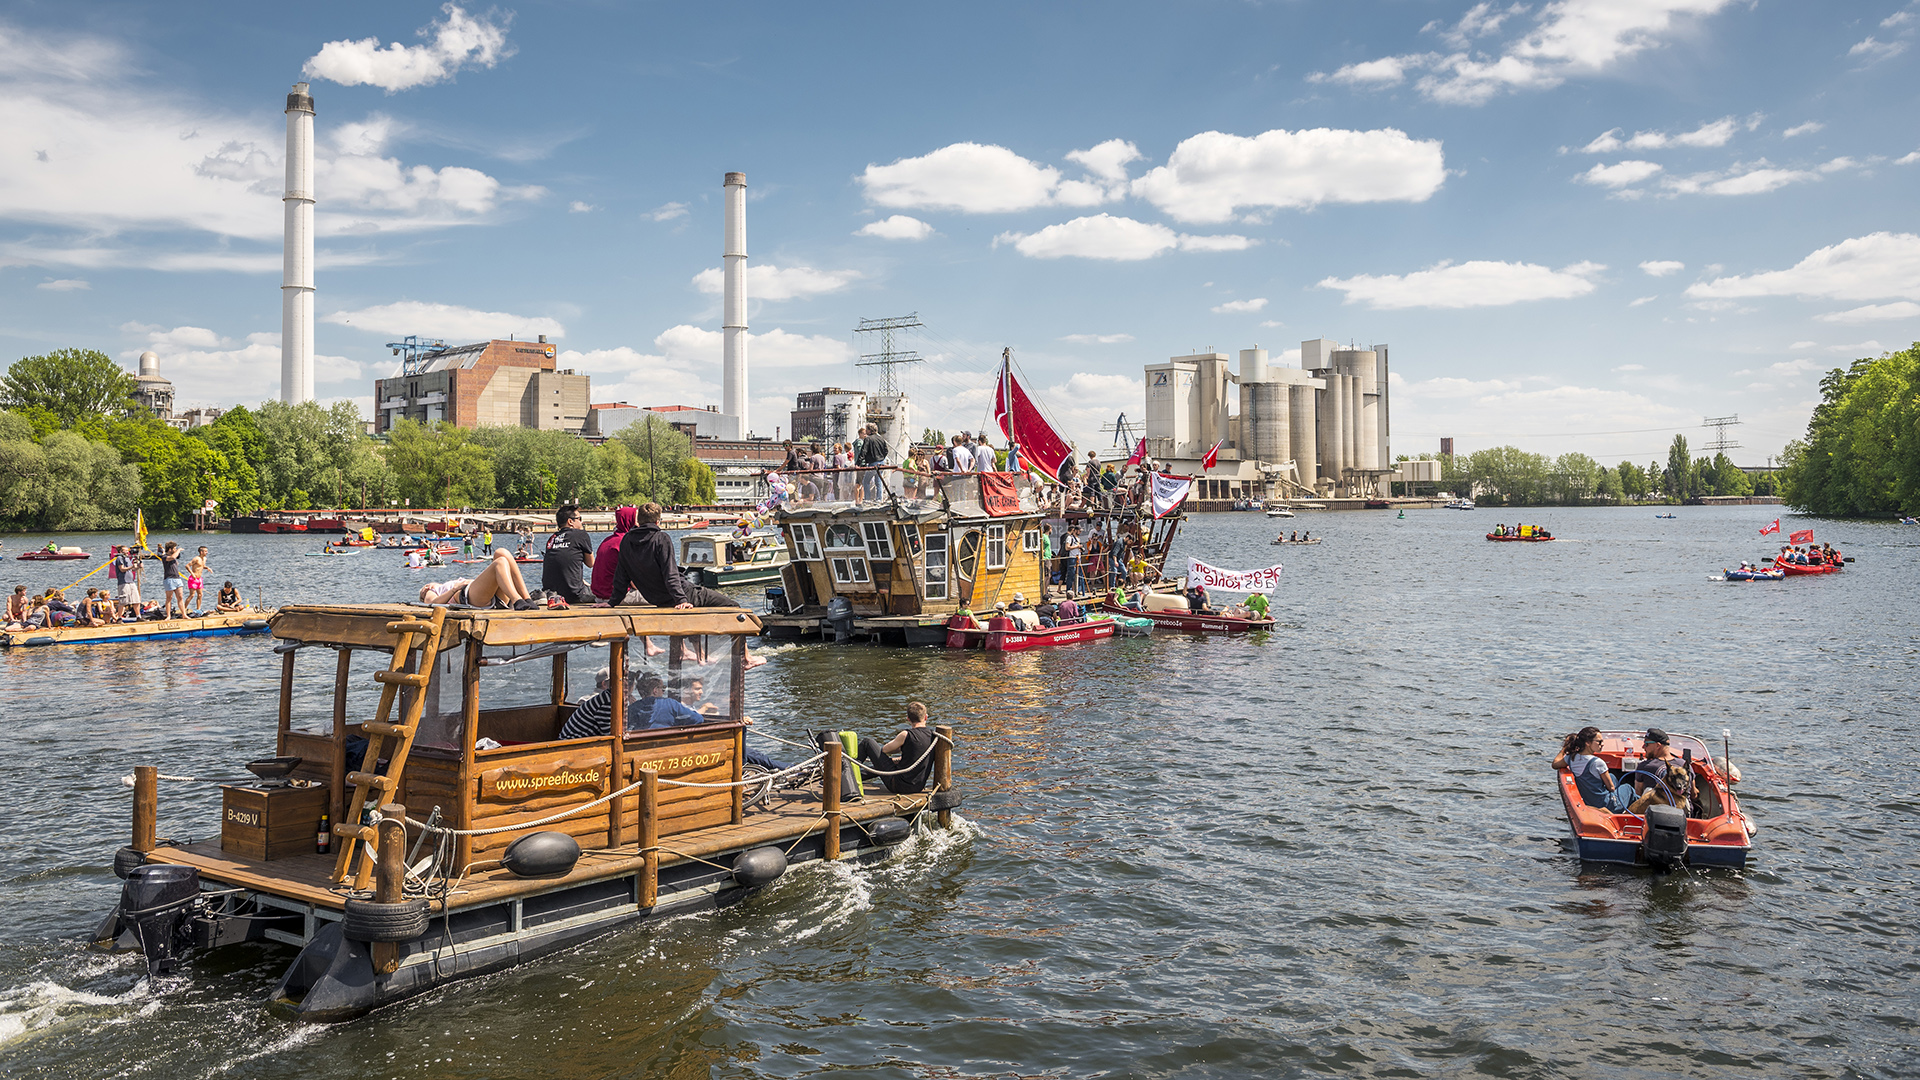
[1780,344,1920,517]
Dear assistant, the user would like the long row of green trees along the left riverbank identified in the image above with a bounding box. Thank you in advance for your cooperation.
[0,350,714,532]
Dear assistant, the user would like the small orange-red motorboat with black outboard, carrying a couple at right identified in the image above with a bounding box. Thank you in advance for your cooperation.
[1559,730,1753,869]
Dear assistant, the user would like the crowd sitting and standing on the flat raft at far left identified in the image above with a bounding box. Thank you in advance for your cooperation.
[4,540,248,630]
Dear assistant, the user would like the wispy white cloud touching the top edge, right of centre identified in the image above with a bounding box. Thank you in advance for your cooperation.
[1308,0,1730,106]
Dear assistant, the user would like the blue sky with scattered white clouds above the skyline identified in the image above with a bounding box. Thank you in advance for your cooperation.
[0,0,1920,463]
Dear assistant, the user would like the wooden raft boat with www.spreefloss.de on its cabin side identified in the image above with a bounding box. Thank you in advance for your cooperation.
[94,603,960,1022]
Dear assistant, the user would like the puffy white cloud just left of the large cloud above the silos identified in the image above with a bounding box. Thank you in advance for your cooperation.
[860,138,1140,213]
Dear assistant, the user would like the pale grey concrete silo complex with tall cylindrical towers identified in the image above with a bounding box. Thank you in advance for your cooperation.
[1146,338,1398,500]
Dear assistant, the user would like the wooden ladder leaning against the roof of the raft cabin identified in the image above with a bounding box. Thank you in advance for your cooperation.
[334,607,447,888]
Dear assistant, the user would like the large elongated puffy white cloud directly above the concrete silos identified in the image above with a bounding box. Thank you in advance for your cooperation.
[1133,127,1446,223]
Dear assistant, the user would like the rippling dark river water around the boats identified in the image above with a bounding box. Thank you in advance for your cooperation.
[0,507,1920,1080]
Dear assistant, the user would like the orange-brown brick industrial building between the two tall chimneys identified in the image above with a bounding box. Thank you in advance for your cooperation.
[372,334,591,434]
